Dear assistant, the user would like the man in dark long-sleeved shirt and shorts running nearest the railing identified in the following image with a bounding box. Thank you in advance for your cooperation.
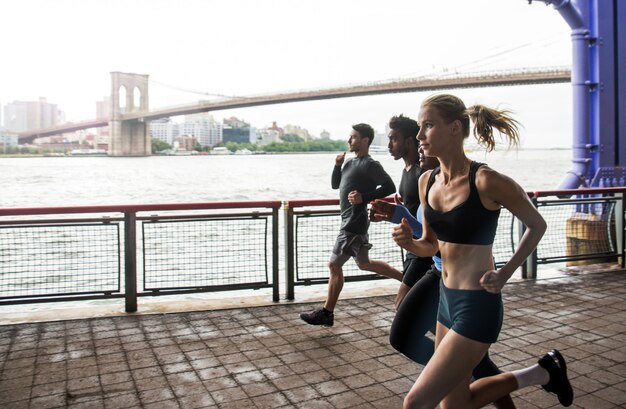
[300,124,402,326]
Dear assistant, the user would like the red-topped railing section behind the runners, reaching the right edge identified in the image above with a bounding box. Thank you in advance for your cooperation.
[283,188,626,294]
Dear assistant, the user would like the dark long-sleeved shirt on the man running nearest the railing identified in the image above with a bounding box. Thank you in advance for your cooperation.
[331,155,396,234]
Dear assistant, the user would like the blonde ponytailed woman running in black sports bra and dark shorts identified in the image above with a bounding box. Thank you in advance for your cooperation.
[393,94,573,409]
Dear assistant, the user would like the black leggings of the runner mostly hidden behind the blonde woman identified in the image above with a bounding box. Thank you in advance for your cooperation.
[389,265,501,379]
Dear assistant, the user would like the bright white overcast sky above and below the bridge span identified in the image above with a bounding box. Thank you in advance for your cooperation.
[0,0,571,146]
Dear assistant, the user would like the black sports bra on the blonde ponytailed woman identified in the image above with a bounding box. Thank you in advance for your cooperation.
[424,161,500,245]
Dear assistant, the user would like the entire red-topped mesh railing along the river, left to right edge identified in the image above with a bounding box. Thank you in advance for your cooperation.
[0,188,626,312]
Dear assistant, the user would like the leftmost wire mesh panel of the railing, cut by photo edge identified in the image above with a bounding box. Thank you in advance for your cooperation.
[0,223,120,299]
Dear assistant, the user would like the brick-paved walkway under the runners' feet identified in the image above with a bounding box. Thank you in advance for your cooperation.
[0,271,626,409]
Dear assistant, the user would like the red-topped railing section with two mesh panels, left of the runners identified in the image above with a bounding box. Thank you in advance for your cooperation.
[0,201,281,312]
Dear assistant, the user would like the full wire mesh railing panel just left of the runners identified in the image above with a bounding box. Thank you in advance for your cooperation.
[141,217,271,291]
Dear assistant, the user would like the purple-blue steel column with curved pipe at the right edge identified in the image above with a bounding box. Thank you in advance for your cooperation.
[532,0,626,189]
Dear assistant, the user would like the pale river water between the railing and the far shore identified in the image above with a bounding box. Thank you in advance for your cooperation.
[0,150,571,208]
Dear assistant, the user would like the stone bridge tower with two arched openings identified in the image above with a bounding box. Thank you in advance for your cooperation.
[109,71,152,156]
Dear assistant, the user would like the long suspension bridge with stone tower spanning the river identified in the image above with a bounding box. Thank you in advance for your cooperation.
[18,67,571,152]
